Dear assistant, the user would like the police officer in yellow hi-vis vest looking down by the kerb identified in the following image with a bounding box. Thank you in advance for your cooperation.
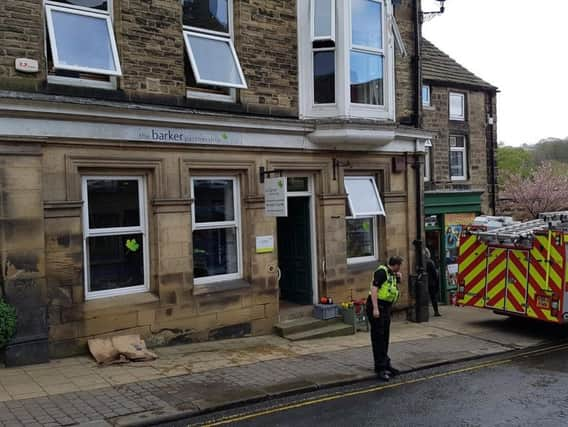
[367,256,403,381]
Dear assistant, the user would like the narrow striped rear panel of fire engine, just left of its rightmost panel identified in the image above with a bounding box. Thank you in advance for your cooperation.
[505,250,529,314]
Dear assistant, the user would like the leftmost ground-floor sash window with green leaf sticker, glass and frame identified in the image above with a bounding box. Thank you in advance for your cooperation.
[82,177,149,299]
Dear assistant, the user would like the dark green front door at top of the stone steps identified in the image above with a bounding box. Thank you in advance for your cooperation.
[278,197,313,304]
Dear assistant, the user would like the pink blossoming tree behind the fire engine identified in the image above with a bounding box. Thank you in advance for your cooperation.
[502,162,568,218]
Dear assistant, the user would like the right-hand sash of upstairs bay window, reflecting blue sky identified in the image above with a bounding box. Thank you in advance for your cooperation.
[349,0,384,105]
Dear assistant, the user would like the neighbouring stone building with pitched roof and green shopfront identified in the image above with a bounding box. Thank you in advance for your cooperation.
[422,39,497,301]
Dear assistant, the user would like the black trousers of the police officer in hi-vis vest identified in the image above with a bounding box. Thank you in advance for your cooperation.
[367,296,392,371]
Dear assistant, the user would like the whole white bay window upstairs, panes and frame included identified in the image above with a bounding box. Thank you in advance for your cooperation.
[297,0,394,120]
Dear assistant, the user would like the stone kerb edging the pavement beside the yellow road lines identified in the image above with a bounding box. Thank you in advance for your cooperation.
[108,350,511,427]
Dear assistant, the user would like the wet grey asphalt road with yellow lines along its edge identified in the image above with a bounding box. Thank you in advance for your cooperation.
[185,346,568,427]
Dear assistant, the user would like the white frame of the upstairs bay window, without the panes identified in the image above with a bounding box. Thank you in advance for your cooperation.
[296,0,395,122]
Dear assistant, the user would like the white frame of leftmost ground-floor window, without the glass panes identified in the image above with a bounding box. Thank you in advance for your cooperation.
[81,175,150,301]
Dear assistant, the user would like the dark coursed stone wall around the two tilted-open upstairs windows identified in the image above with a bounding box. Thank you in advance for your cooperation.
[0,0,298,116]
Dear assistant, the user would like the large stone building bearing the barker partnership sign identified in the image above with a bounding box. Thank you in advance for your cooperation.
[0,0,429,363]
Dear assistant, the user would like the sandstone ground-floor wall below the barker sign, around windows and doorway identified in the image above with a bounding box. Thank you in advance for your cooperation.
[32,143,416,356]
